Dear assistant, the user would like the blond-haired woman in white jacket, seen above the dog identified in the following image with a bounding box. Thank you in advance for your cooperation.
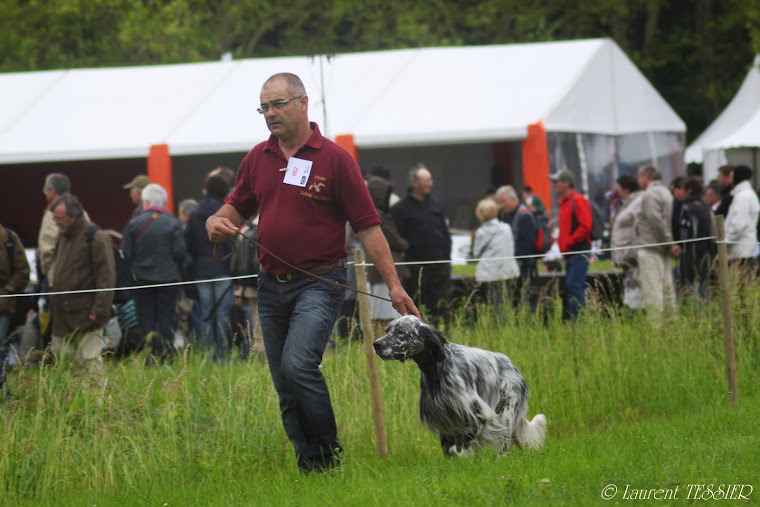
[472,199,520,305]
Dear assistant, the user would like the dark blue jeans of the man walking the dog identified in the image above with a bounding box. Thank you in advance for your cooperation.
[258,268,346,471]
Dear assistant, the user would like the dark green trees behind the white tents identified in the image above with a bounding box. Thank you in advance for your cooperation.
[0,0,760,140]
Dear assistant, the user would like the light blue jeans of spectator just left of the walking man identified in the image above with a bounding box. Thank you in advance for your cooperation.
[198,280,235,359]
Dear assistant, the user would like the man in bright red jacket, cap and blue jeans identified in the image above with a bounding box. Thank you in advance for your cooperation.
[549,169,593,319]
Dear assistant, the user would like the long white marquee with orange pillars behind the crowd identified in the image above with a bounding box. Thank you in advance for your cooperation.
[0,39,685,243]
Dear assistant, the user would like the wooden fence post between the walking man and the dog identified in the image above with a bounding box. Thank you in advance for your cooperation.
[354,248,388,458]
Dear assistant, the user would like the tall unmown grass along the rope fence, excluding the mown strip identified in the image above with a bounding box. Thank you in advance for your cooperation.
[0,276,760,505]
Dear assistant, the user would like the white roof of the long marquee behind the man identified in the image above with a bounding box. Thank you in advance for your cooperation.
[0,39,685,163]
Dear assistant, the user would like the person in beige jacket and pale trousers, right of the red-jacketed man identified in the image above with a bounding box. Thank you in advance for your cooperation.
[634,164,680,316]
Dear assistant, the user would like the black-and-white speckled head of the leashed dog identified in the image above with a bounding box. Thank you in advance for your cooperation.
[374,315,446,362]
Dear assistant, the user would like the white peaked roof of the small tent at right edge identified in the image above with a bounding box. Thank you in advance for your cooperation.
[686,54,760,162]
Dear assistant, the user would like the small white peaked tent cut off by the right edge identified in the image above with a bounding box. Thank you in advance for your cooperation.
[686,55,760,180]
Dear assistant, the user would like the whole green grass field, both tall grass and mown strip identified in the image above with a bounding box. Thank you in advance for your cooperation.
[0,288,760,506]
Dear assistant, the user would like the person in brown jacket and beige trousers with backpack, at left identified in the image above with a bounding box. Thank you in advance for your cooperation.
[50,194,116,371]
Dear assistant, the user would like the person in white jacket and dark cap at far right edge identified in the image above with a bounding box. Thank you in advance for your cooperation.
[726,165,760,265]
